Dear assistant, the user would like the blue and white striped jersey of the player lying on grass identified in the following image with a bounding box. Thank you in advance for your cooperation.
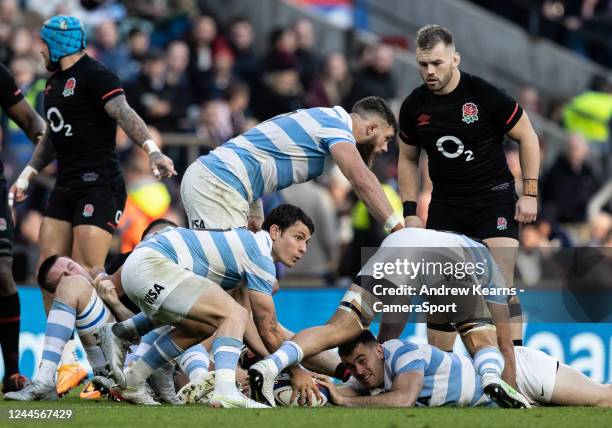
[348,339,493,407]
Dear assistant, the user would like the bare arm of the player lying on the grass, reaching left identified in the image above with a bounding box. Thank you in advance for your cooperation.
[317,371,424,407]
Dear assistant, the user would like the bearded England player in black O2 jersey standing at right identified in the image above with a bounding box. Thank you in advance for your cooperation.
[398,25,540,388]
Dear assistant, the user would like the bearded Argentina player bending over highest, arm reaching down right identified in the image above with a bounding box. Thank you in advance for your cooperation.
[181,97,403,234]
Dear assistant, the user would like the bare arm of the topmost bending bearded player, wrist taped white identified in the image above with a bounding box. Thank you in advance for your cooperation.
[330,142,404,231]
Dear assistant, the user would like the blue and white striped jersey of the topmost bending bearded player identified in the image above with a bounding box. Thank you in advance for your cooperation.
[198,106,356,203]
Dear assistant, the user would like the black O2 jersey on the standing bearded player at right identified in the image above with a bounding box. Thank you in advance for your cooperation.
[399,72,523,200]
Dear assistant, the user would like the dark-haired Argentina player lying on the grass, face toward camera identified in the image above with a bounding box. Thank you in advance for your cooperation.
[318,330,612,407]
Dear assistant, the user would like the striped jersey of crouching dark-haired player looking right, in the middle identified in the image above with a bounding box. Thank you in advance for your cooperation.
[135,227,276,295]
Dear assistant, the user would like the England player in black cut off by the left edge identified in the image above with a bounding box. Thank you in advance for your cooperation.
[0,64,45,392]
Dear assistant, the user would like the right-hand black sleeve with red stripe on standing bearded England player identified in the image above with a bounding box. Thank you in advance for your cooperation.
[478,79,523,134]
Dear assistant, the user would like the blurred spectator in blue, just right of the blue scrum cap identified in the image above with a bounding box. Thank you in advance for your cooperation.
[95,21,133,82]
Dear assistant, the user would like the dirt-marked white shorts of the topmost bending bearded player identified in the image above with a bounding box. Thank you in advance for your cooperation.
[181,161,249,229]
